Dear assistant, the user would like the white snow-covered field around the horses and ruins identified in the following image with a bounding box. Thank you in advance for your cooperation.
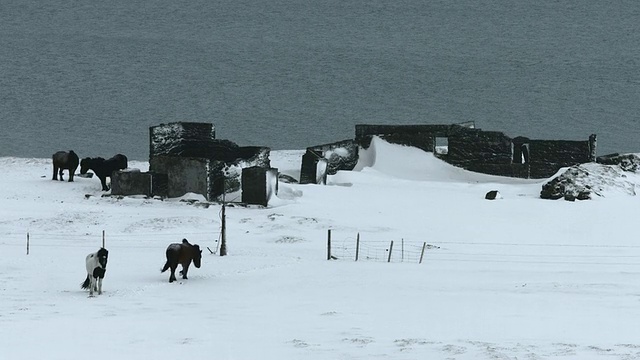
[0,141,640,360]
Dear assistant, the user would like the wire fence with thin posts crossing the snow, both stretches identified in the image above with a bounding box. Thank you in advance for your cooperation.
[5,228,640,271]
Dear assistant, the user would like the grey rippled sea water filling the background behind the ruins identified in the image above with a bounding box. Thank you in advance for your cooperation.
[0,0,640,160]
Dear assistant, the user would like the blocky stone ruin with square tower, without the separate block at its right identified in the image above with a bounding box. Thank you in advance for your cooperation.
[116,122,270,201]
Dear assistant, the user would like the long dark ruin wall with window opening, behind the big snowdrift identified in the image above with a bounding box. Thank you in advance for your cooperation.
[356,124,596,178]
